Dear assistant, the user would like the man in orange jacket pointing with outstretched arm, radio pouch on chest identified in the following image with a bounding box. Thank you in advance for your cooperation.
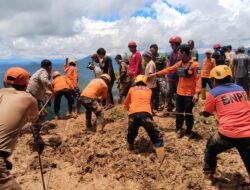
[150,44,201,138]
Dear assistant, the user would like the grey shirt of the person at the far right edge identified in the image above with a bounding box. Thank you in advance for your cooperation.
[233,53,250,78]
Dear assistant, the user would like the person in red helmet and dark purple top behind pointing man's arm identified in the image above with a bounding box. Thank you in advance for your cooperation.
[166,36,182,112]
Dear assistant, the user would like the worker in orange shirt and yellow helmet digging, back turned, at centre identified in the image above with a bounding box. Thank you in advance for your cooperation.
[124,75,163,150]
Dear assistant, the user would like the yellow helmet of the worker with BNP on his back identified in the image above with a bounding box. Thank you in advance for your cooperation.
[210,65,232,79]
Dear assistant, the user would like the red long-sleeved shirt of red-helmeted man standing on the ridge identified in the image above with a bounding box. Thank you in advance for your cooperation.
[128,51,142,78]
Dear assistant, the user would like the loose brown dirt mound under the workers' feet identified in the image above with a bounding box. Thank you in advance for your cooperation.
[12,104,250,190]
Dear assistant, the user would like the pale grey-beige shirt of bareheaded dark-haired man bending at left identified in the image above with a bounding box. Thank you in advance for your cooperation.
[27,68,50,100]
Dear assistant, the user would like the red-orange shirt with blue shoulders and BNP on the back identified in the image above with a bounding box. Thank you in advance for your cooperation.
[204,83,250,138]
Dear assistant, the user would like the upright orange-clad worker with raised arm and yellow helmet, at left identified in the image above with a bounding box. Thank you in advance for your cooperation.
[63,59,80,104]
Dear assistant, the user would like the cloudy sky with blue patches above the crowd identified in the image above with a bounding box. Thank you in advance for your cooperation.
[0,0,250,59]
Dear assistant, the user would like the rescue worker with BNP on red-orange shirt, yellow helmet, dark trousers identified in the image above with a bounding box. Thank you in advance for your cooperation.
[201,65,250,178]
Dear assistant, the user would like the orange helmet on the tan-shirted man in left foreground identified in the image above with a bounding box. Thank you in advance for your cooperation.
[4,67,30,85]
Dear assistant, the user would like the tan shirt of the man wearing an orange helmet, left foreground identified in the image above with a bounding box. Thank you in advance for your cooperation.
[0,88,38,153]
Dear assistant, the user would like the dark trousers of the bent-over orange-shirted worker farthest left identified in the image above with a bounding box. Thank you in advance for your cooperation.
[54,89,73,115]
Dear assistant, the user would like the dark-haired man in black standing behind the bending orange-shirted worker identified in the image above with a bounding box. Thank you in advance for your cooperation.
[96,48,115,109]
